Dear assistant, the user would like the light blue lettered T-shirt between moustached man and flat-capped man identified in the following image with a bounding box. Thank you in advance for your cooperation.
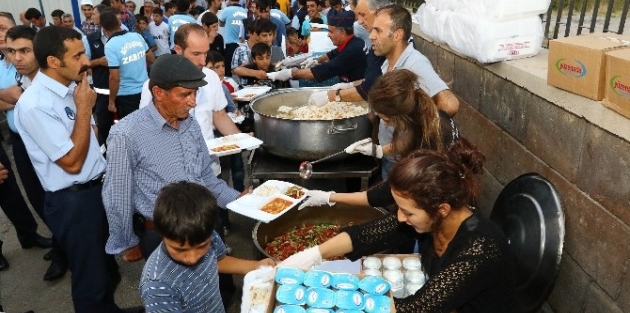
[105,32,149,96]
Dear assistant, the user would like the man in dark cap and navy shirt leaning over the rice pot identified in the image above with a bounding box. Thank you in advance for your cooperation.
[277,10,367,97]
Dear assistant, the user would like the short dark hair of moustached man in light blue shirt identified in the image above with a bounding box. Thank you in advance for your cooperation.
[33,26,81,69]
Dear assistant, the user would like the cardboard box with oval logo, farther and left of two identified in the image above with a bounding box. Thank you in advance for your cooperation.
[547,33,630,100]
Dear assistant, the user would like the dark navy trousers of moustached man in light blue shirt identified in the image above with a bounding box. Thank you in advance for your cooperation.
[44,185,121,313]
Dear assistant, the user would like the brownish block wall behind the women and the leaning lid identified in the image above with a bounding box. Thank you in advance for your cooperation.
[414,31,630,312]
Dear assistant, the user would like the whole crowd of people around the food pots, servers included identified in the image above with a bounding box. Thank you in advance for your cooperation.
[0,0,513,312]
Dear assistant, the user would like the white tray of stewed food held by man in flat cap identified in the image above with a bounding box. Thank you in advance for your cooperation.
[227,180,306,223]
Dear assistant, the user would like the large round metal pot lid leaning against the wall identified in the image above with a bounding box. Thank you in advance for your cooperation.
[490,174,564,313]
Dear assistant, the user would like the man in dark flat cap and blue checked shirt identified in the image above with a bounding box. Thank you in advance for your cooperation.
[103,54,248,270]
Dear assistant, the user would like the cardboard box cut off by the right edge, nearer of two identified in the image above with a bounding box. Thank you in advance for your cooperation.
[602,49,630,118]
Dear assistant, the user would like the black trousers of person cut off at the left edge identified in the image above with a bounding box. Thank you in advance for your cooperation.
[0,144,37,245]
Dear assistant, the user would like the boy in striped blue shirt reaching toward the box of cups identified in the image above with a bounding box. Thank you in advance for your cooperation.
[140,181,275,313]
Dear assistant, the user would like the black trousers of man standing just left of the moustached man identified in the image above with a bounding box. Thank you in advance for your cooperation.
[13,133,66,262]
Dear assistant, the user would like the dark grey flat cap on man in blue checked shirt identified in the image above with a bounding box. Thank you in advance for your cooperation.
[149,54,208,88]
